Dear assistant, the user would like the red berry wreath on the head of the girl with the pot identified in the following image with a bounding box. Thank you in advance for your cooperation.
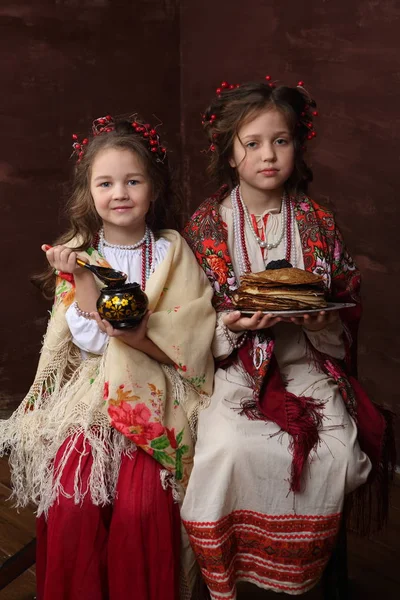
[72,113,167,163]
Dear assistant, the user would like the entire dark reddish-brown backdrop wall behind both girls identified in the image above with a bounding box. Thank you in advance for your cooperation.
[0,0,400,450]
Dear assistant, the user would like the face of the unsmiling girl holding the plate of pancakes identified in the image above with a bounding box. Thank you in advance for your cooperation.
[229,108,294,192]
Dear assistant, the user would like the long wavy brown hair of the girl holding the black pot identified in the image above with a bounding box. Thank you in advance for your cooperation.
[32,116,183,298]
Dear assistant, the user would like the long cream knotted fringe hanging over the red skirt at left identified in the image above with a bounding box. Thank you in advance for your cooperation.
[0,339,136,516]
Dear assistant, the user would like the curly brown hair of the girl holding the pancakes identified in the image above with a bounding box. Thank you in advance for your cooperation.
[203,82,316,196]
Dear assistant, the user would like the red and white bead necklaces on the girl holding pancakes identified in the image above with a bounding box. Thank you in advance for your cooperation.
[231,186,296,275]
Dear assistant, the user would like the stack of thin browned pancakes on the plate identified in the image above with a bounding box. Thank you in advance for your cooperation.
[233,267,327,311]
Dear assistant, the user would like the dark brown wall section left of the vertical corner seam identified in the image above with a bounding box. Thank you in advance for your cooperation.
[0,0,180,411]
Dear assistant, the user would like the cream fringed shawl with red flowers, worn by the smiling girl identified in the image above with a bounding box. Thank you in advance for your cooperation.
[0,230,215,514]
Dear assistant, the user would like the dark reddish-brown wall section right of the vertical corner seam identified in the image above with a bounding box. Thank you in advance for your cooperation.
[181,0,400,450]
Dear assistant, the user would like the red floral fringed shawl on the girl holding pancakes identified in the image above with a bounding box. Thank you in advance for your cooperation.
[183,186,394,528]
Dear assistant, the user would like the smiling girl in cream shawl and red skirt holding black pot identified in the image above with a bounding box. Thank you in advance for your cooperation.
[0,117,215,600]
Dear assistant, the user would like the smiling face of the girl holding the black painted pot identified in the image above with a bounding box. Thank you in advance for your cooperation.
[90,148,153,233]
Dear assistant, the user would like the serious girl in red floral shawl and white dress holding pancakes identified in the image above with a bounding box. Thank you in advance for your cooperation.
[182,77,393,600]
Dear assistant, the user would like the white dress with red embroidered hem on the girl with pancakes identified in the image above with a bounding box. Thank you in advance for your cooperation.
[182,205,371,600]
